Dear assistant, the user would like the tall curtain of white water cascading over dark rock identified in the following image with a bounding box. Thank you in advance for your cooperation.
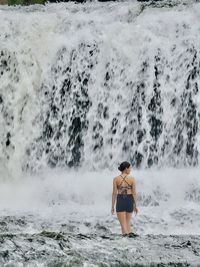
[0,1,200,174]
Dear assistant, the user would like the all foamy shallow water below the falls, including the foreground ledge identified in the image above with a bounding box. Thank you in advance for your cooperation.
[0,169,200,266]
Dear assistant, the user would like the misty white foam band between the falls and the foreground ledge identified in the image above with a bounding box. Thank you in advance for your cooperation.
[0,169,200,234]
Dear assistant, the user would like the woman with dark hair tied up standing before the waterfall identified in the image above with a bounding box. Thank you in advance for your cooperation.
[112,161,138,237]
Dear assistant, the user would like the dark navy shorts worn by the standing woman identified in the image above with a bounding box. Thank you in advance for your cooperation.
[116,194,134,212]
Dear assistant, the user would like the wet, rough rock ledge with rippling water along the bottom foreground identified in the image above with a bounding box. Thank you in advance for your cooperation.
[0,216,200,266]
